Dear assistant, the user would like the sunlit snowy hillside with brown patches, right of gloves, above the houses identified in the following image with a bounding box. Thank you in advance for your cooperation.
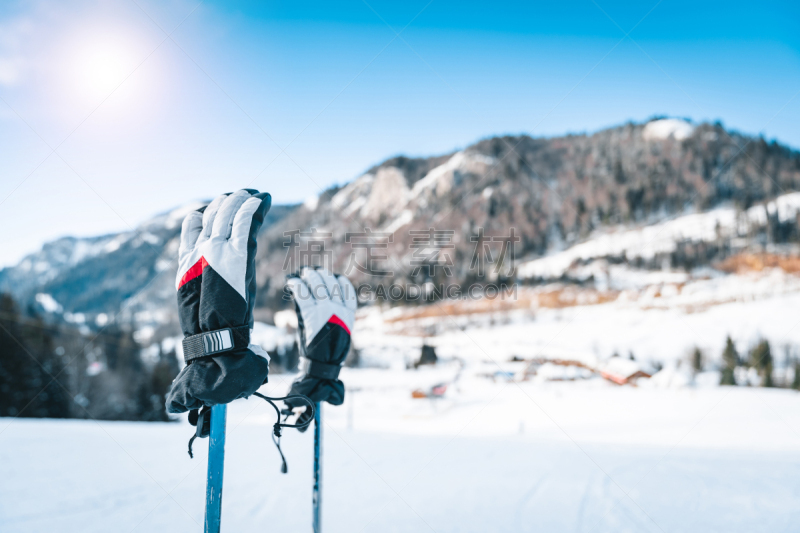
[355,266,800,366]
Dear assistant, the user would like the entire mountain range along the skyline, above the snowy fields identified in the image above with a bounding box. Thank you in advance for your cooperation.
[0,119,800,336]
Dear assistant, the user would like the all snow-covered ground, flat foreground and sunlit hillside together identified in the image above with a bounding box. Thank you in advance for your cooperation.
[7,186,800,533]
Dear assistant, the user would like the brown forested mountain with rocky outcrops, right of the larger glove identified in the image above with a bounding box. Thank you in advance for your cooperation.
[252,119,800,306]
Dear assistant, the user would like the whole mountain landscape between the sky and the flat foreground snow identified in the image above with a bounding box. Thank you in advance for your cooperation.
[0,119,800,430]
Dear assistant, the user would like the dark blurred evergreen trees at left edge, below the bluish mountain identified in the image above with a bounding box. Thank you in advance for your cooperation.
[0,294,175,420]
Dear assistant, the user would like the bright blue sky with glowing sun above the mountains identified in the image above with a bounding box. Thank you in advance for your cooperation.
[0,0,800,266]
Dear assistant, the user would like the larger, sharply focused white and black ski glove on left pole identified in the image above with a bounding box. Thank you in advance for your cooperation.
[166,189,271,413]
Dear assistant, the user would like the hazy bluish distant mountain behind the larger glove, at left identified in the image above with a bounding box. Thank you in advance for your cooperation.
[0,203,294,330]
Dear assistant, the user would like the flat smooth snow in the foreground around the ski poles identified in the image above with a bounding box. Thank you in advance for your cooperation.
[0,376,800,533]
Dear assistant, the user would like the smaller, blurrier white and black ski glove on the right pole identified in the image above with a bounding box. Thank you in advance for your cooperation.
[286,267,357,421]
